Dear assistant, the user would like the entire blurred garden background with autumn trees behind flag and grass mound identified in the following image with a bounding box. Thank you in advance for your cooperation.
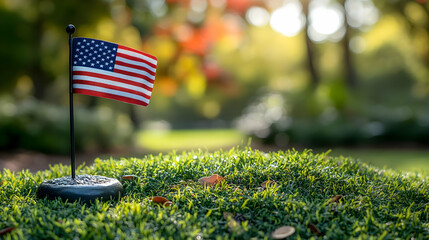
[0,0,429,171]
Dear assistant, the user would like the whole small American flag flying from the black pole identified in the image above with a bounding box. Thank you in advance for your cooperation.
[72,38,157,106]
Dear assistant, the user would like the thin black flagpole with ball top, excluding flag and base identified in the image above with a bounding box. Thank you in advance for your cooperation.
[66,24,76,179]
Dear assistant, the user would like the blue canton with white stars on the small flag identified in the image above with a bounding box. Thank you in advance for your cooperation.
[73,38,118,71]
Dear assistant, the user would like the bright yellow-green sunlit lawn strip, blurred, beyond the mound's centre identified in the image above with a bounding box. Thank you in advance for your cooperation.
[136,129,245,152]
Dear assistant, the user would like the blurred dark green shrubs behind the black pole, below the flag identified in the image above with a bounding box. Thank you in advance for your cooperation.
[0,98,132,154]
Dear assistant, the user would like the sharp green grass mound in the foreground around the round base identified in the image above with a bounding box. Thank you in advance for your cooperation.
[0,148,429,239]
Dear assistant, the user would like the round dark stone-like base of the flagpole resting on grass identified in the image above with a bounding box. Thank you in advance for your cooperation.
[36,175,124,203]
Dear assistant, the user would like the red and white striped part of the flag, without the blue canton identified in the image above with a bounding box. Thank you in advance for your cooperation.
[73,45,157,106]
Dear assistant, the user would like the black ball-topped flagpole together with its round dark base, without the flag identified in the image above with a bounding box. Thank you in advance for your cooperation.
[36,24,124,203]
